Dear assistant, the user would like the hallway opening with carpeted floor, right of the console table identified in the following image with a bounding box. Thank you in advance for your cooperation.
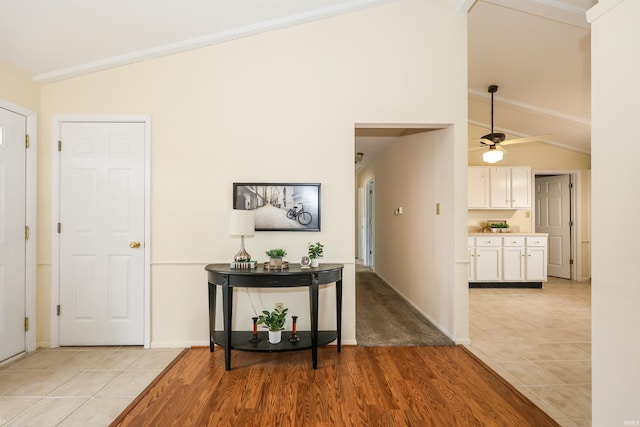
[354,124,455,345]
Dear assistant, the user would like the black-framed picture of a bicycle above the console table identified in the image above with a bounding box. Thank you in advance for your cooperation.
[233,182,320,231]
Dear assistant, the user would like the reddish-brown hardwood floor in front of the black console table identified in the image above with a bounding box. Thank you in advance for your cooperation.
[111,346,558,427]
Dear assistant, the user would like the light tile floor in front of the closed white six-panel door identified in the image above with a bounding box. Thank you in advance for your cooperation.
[0,347,182,427]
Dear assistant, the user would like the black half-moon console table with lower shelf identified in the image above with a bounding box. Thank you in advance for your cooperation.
[205,264,344,371]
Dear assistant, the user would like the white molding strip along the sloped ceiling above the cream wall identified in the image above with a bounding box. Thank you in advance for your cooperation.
[33,0,397,83]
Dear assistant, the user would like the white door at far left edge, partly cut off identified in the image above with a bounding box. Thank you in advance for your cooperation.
[0,108,26,361]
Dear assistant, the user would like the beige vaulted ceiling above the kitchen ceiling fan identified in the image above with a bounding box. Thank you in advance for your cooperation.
[468,0,596,153]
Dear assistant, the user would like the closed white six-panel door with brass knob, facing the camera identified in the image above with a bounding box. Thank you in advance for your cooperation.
[59,122,145,345]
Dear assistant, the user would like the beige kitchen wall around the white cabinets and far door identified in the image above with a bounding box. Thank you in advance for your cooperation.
[467,124,591,279]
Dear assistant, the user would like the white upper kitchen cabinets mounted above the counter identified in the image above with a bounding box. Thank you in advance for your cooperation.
[468,166,531,209]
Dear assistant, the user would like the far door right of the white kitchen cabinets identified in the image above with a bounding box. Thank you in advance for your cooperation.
[535,175,571,279]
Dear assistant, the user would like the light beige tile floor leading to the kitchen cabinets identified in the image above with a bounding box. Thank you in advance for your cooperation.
[468,277,591,427]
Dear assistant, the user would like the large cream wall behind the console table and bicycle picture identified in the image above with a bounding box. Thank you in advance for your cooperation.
[38,0,468,346]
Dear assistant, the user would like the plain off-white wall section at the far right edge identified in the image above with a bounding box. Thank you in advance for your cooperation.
[589,0,640,426]
